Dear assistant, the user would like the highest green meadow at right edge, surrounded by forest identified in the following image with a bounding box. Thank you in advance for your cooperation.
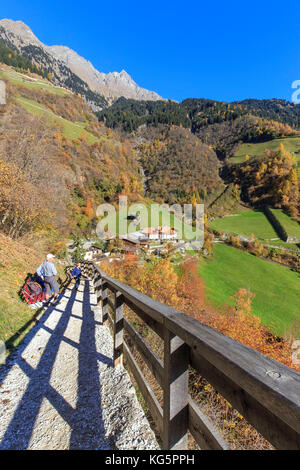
[230,137,300,165]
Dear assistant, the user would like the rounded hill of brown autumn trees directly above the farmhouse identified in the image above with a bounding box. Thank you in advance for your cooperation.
[138,126,224,204]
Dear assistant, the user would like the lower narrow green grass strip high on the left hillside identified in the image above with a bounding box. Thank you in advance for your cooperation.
[17,96,98,144]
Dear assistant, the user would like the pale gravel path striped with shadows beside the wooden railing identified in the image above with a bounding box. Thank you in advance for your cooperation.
[0,280,159,450]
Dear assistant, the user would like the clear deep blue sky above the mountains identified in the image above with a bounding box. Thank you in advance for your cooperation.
[0,0,300,101]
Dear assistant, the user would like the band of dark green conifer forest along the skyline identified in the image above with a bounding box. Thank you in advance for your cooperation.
[97,98,300,133]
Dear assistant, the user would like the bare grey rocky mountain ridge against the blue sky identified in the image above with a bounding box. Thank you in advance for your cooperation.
[0,19,162,111]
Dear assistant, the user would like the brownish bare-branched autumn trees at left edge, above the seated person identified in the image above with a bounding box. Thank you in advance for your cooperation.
[0,108,67,237]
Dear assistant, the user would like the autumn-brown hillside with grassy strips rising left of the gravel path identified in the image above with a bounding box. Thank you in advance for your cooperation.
[0,65,147,354]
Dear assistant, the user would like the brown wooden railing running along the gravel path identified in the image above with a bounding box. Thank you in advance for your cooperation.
[84,262,300,450]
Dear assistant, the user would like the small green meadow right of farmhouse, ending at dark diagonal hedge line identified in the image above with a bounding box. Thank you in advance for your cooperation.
[210,210,278,240]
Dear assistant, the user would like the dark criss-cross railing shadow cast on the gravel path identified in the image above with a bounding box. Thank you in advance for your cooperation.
[0,280,113,449]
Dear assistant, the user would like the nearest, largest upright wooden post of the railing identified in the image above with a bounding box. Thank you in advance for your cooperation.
[162,327,189,450]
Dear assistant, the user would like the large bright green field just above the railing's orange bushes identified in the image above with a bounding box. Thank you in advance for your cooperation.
[198,244,300,335]
